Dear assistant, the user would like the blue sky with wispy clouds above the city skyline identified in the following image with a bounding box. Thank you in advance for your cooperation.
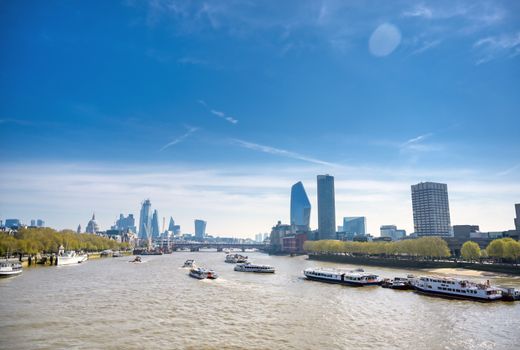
[0,0,520,236]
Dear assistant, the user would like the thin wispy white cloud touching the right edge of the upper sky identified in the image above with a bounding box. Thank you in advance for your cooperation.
[473,32,520,65]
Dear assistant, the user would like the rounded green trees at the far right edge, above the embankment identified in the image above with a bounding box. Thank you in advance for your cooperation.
[460,238,520,262]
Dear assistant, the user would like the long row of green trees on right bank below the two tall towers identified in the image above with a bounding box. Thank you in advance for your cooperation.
[303,237,450,258]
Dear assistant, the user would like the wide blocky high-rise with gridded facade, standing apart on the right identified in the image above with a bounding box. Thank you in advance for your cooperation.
[412,182,451,236]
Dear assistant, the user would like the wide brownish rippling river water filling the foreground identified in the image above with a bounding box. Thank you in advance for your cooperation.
[0,252,520,349]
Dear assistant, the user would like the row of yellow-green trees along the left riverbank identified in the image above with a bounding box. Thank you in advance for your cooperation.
[0,228,128,255]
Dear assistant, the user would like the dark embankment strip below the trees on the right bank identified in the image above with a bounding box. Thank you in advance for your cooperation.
[308,254,520,276]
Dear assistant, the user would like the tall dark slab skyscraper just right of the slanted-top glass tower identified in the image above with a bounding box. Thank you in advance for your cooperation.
[318,175,336,239]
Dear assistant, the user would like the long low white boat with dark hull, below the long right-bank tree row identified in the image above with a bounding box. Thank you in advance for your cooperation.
[303,268,381,287]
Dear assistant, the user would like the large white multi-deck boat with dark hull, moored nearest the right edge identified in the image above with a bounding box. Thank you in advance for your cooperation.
[412,276,502,301]
